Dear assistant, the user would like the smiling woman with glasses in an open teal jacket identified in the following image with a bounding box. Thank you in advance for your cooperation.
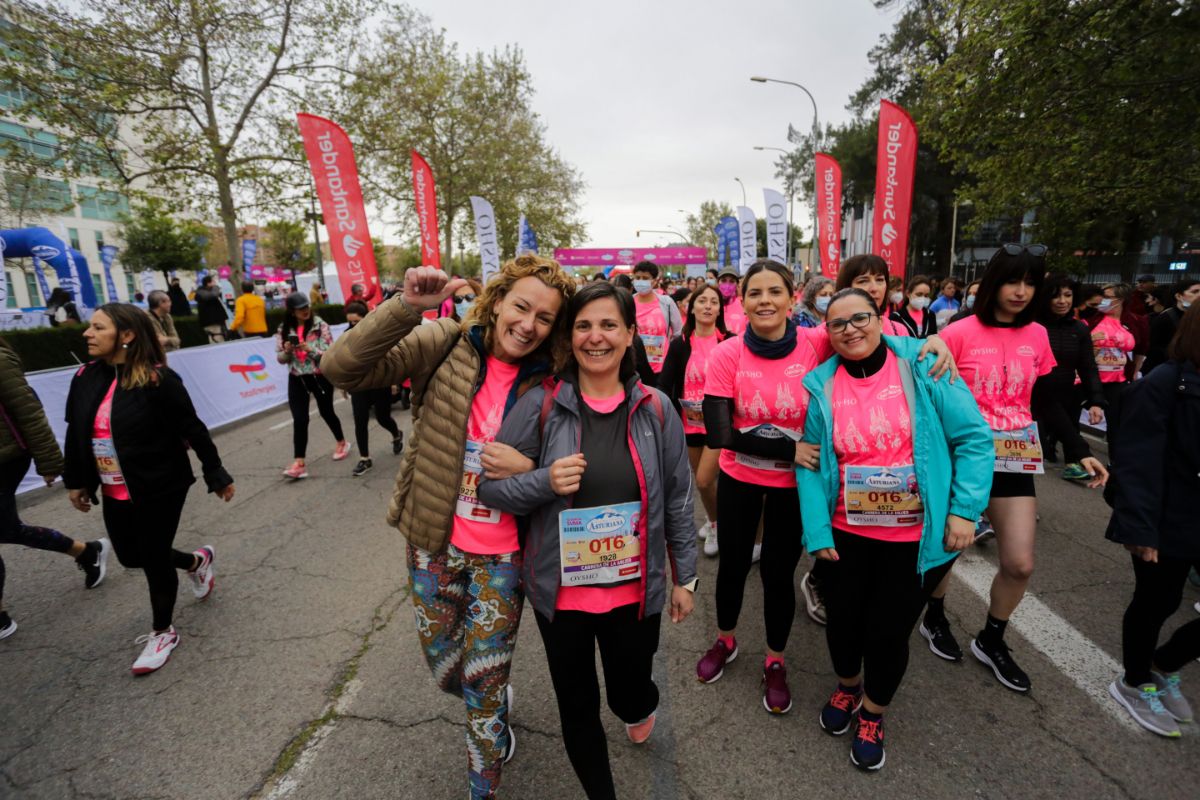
[797,289,995,770]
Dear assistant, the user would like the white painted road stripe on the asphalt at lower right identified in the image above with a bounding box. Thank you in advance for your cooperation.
[952,554,1141,730]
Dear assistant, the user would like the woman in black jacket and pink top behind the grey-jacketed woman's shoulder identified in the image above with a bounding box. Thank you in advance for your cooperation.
[659,284,728,555]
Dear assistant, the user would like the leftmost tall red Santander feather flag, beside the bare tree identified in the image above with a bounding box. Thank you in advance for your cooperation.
[296,114,380,308]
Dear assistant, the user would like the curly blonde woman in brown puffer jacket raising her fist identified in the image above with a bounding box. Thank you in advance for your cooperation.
[322,255,575,798]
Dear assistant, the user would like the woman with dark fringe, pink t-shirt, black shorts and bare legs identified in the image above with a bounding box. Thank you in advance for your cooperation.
[922,245,1108,692]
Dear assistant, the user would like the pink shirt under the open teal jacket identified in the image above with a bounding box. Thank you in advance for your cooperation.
[833,350,924,542]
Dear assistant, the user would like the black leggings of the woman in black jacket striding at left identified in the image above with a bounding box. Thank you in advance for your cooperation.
[103,489,196,631]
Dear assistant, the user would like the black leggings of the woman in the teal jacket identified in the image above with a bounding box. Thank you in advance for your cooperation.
[825,528,954,705]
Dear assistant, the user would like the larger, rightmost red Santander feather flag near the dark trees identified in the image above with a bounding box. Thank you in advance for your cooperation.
[871,100,917,277]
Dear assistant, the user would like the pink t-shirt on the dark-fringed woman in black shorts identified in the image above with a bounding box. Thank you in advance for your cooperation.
[942,315,1057,431]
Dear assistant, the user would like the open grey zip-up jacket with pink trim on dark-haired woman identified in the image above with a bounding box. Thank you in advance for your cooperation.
[479,375,696,619]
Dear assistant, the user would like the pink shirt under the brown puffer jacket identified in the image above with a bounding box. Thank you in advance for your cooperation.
[450,355,521,555]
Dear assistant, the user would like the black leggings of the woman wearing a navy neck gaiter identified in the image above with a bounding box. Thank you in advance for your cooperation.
[716,471,803,652]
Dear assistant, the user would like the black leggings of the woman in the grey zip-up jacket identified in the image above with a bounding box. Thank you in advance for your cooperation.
[535,606,662,800]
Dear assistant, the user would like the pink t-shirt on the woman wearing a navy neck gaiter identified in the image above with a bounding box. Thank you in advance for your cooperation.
[704,329,820,488]
